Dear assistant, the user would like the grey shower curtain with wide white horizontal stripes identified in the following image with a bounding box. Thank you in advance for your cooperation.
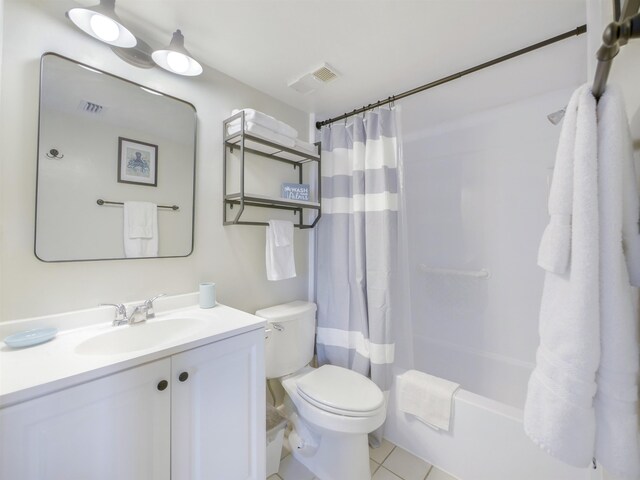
[317,109,400,446]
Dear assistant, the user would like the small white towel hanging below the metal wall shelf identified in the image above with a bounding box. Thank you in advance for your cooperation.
[265,220,296,280]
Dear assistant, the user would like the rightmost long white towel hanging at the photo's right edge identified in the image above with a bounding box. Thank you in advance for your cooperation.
[594,86,640,479]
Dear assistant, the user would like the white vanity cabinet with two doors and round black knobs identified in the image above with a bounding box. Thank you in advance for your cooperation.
[0,329,265,480]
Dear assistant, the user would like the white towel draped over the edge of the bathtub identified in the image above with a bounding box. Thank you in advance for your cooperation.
[398,370,460,432]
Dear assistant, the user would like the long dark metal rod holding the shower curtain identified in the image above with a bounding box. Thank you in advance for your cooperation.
[316,24,584,129]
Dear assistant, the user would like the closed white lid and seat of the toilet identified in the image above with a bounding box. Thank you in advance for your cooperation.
[296,365,384,417]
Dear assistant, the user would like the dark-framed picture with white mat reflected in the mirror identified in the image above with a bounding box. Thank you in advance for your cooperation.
[118,137,158,187]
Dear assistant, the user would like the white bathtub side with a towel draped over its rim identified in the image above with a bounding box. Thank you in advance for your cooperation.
[385,370,603,480]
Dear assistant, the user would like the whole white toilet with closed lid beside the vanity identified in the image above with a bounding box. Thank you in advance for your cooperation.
[256,301,386,480]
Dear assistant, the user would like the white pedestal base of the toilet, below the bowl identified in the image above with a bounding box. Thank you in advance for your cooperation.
[291,431,371,480]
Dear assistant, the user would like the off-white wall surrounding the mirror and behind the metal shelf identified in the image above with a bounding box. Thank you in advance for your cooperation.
[0,0,309,321]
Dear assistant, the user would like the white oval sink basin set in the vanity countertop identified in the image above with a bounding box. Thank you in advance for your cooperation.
[75,318,207,355]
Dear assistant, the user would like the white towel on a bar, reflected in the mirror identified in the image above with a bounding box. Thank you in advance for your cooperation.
[123,202,158,258]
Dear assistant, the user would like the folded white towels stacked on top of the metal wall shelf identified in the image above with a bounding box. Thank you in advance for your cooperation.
[227,108,318,154]
